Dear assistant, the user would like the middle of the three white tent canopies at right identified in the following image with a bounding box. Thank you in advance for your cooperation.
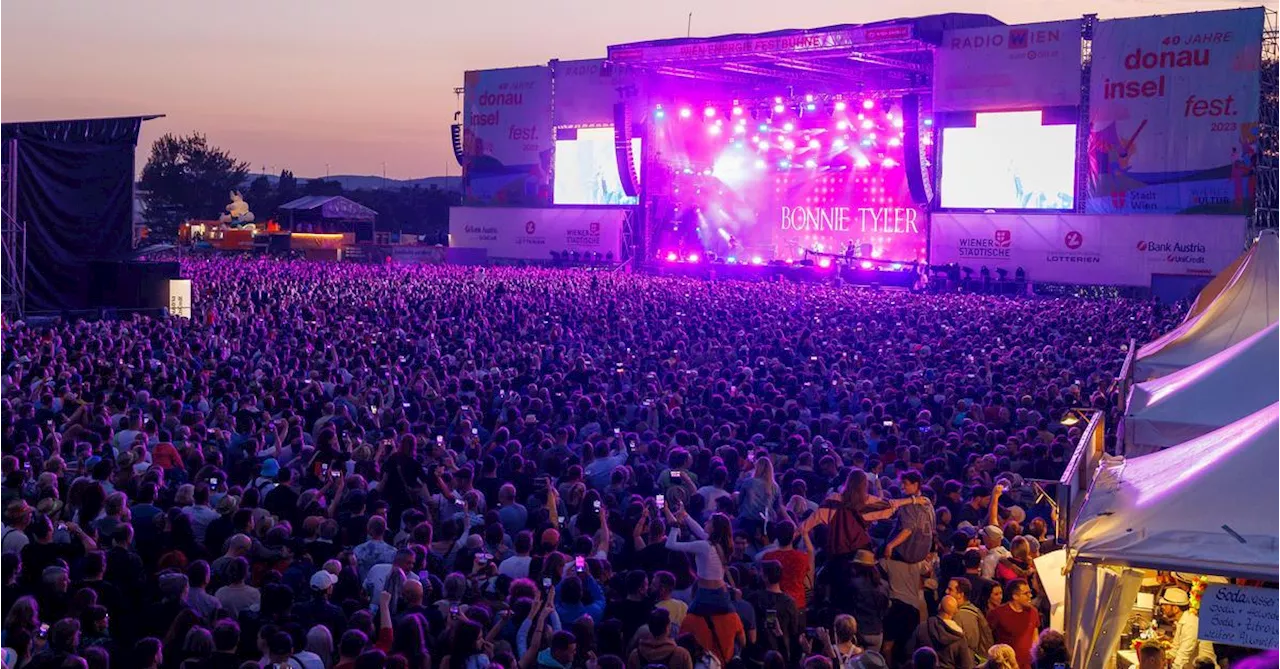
[1124,321,1280,457]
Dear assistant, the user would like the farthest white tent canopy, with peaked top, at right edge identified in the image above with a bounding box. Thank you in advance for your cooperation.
[1134,230,1280,381]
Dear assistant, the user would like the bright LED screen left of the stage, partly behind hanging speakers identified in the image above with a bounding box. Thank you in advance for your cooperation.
[556,128,640,205]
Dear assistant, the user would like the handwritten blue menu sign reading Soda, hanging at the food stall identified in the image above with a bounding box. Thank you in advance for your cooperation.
[1199,585,1280,650]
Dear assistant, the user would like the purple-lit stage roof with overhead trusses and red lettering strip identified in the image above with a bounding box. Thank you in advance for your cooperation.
[608,14,1004,90]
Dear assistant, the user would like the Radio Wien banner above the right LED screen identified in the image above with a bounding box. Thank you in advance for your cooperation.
[933,19,1080,111]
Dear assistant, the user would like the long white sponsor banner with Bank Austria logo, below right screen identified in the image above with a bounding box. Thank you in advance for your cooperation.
[929,212,1245,287]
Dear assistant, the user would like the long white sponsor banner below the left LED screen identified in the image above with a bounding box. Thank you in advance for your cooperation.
[449,207,627,261]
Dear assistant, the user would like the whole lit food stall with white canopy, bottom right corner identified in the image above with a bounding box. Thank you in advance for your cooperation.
[1066,403,1280,668]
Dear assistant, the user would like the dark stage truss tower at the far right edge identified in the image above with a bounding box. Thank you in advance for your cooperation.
[1249,9,1280,235]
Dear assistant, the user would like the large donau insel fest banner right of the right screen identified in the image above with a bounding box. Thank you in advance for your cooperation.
[1085,8,1263,214]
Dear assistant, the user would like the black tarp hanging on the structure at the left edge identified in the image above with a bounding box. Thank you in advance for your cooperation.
[0,116,143,311]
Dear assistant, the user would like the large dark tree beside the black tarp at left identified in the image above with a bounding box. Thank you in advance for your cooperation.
[138,133,248,234]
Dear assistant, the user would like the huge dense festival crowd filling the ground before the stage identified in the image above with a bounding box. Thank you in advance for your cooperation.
[0,258,1178,669]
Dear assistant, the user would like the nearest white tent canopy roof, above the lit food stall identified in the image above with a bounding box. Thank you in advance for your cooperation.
[1070,403,1280,581]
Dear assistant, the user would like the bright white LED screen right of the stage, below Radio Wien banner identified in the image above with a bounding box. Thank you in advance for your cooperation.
[941,111,1075,210]
